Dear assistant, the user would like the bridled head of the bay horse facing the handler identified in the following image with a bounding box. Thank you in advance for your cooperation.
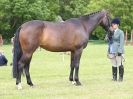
[100,10,111,32]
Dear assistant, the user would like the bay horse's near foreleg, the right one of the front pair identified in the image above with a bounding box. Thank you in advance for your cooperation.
[74,48,83,85]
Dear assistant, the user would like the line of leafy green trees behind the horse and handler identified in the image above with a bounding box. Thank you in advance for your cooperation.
[0,0,133,39]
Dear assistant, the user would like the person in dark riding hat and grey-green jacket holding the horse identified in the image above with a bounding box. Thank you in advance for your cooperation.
[108,18,124,82]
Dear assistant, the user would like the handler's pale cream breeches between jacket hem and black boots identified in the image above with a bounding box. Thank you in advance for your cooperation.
[108,54,123,67]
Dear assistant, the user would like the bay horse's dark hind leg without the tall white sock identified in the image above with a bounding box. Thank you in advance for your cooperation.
[24,57,33,86]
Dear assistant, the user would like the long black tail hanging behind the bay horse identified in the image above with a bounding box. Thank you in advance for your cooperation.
[13,27,23,78]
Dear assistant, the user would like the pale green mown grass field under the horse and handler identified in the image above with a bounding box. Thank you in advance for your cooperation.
[0,41,133,99]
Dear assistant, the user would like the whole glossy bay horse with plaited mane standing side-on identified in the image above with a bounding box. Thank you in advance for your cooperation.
[13,10,111,89]
